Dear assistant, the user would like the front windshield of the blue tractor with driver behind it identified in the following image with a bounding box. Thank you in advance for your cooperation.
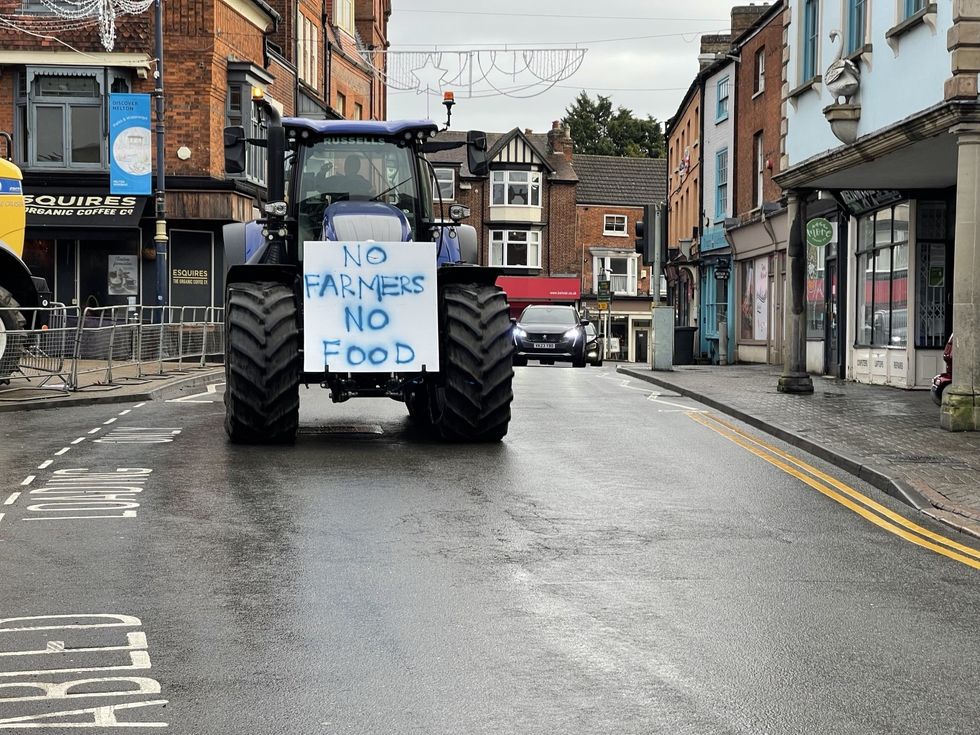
[296,136,419,247]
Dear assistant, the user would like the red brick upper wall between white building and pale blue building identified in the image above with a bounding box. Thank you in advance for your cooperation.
[734,14,783,216]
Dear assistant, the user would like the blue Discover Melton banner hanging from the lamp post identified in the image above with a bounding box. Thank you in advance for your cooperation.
[109,94,153,194]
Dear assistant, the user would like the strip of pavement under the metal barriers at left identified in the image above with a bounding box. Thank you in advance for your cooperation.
[0,360,225,413]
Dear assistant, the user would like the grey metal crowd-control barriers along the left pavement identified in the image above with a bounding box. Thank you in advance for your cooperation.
[0,304,224,400]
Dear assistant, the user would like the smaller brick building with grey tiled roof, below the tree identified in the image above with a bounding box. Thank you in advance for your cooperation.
[572,154,667,362]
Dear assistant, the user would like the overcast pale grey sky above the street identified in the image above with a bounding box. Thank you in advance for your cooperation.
[388,0,747,132]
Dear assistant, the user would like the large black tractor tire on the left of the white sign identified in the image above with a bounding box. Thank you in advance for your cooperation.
[225,283,300,444]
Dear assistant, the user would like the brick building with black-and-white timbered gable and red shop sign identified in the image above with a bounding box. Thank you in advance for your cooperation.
[429,122,582,314]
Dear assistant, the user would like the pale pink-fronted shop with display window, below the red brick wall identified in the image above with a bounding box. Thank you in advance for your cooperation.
[726,210,788,365]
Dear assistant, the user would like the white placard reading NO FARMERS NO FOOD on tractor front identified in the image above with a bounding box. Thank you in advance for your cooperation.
[303,242,439,373]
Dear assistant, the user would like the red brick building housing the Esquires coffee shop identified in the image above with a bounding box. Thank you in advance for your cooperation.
[0,0,390,306]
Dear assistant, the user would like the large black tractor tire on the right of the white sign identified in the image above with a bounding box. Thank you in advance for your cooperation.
[430,283,514,442]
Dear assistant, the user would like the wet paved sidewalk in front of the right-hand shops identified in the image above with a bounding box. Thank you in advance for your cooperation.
[618,365,980,537]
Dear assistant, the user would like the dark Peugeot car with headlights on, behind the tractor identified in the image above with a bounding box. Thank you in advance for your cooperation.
[512,304,588,367]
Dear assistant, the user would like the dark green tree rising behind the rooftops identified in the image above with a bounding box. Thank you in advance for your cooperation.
[562,91,664,158]
